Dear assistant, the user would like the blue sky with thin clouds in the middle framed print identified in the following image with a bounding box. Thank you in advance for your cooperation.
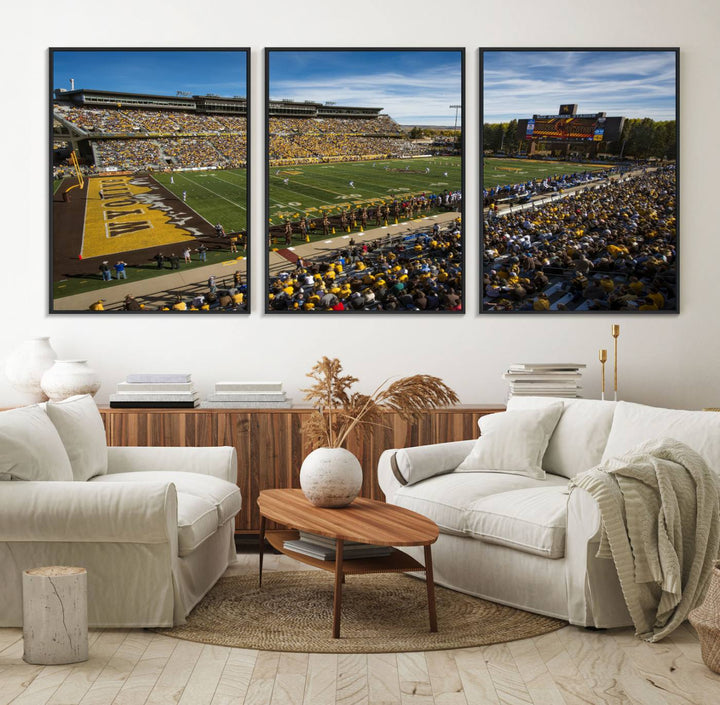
[269,50,462,127]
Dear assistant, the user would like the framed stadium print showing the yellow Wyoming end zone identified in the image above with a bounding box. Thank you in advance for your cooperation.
[49,48,249,315]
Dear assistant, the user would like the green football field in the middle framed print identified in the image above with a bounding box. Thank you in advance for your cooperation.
[269,157,462,225]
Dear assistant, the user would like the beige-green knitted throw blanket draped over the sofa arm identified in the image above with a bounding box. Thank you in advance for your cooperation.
[570,439,720,641]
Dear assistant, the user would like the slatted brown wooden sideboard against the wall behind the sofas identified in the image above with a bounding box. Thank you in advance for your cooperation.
[100,405,504,533]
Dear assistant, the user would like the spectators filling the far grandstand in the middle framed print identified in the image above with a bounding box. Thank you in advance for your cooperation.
[270,115,427,163]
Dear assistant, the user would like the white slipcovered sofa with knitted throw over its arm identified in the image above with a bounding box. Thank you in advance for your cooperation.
[378,397,720,628]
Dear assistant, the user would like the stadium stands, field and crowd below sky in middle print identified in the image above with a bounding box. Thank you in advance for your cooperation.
[267,95,463,311]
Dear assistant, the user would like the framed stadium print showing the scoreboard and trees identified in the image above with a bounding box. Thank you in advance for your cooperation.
[480,49,679,314]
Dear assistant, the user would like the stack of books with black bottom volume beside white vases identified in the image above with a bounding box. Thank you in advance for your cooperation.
[110,372,200,409]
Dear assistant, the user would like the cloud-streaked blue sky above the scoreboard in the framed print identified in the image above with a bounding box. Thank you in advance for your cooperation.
[483,51,675,122]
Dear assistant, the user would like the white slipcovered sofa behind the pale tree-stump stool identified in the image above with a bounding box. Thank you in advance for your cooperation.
[0,396,241,627]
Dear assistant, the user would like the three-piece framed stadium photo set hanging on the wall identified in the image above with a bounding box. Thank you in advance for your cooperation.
[49,48,679,316]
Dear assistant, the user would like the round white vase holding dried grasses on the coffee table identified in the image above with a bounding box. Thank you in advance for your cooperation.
[300,448,362,507]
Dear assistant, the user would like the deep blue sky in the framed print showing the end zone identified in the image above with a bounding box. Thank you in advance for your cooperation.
[53,50,247,98]
